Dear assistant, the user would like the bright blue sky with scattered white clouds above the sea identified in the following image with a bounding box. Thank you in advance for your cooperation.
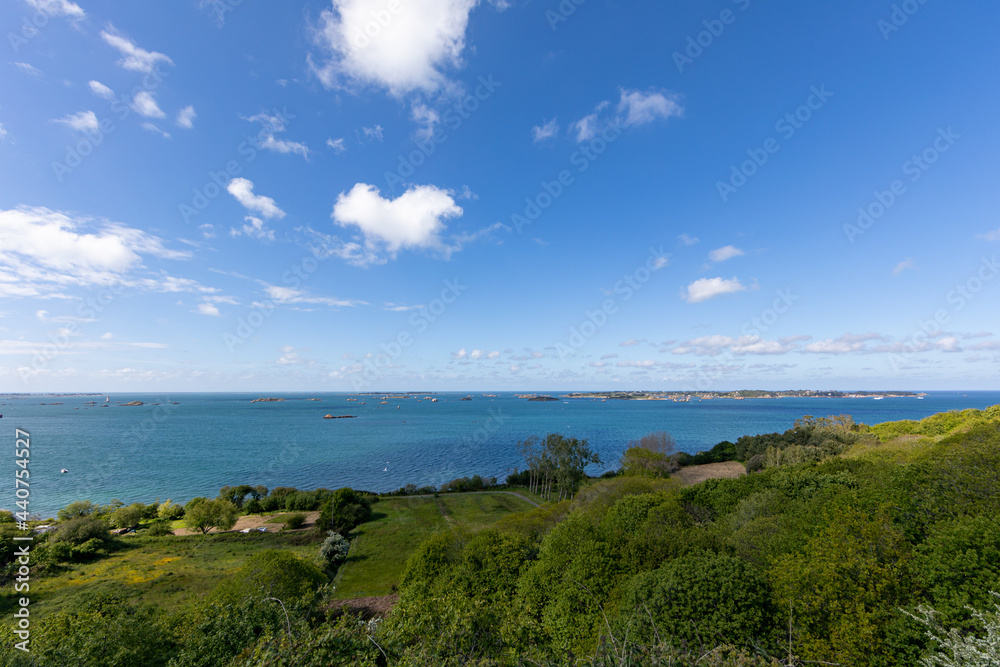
[0,0,1000,392]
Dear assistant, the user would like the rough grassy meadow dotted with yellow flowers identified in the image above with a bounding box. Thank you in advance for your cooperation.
[0,532,320,618]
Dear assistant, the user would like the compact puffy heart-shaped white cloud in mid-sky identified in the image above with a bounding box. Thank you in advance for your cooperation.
[332,183,462,264]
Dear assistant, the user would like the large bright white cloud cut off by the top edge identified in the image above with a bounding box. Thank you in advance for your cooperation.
[309,0,479,96]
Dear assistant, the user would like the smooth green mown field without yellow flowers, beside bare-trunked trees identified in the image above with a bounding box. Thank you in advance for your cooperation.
[335,493,532,599]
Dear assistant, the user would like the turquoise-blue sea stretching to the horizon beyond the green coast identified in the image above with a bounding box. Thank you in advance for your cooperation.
[0,392,1000,516]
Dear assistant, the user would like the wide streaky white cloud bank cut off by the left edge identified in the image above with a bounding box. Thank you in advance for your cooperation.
[0,206,189,296]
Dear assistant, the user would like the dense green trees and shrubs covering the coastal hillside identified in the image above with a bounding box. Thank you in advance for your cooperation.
[0,406,1000,667]
